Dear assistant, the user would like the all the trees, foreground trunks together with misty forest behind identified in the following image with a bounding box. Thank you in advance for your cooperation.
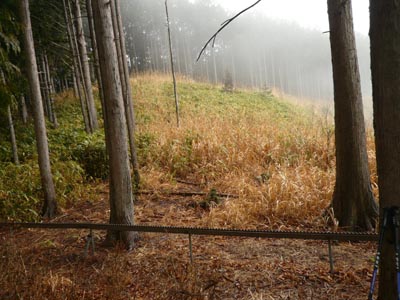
[0,0,400,300]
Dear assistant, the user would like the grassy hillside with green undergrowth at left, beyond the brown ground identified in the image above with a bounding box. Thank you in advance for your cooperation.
[0,75,375,228]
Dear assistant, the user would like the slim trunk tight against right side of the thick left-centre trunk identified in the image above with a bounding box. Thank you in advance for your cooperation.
[115,0,140,189]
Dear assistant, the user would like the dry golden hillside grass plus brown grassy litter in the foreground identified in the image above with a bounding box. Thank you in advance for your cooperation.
[0,75,376,300]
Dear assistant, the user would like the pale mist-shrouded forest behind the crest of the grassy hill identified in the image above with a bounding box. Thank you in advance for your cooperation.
[121,0,372,104]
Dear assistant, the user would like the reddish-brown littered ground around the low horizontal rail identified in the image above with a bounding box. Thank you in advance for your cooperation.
[0,184,376,300]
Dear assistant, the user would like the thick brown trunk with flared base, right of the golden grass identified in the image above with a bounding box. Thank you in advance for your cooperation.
[328,0,378,230]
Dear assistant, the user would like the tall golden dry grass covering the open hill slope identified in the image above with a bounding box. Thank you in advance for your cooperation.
[132,74,376,228]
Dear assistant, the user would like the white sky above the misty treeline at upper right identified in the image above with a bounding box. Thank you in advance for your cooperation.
[213,0,369,35]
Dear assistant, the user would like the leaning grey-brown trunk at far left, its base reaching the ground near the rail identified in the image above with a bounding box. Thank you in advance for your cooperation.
[21,0,57,218]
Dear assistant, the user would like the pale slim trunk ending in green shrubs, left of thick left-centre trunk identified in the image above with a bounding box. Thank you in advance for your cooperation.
[74,0,99,131]
